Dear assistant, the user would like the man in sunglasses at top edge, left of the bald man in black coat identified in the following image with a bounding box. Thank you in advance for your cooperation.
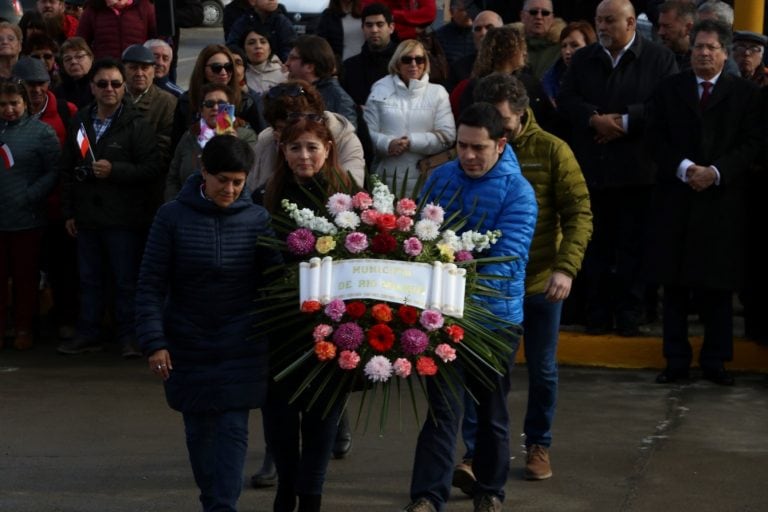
[520,0,560,80]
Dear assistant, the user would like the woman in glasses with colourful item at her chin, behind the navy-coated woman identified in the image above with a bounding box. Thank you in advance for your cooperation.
[165,83,256,201]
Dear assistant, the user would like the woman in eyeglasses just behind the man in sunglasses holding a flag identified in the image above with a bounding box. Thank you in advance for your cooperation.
[53,37,93,108]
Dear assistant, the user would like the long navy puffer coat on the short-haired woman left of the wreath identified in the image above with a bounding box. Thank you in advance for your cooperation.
[136,175,280,412]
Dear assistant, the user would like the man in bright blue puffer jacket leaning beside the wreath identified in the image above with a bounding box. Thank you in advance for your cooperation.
[404,103,538,512]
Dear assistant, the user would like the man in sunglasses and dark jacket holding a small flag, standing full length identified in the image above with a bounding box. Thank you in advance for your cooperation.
[58,59,164,358]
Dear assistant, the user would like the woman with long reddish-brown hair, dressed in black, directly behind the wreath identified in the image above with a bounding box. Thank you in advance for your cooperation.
[262,116,354,512]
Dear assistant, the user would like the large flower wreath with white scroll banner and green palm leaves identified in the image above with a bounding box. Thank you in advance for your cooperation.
[260,177,511,428]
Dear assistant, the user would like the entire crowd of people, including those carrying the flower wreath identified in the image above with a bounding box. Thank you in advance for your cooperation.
[0,0,768,512]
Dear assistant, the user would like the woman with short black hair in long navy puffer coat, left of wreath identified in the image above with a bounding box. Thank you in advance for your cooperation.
[136,135,280,512]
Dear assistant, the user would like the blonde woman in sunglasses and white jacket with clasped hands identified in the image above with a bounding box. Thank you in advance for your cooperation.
[363,39,456,195]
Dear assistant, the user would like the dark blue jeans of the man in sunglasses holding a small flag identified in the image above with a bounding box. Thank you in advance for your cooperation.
[77,228,145,343]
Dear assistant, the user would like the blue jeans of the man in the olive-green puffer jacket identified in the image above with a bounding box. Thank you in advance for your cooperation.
[461,293,563,459]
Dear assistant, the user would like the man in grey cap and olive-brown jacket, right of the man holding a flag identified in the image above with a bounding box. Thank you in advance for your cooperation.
[123,44,176,168]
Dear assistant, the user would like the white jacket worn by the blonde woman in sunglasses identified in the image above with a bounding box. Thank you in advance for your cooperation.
[363,73,456,195]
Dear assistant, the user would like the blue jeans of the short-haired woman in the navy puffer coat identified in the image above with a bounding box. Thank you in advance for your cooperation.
[184,409,249,512]
